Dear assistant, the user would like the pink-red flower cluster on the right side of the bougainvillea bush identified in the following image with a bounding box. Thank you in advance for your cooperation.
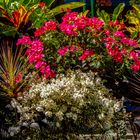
[103,21,139,68]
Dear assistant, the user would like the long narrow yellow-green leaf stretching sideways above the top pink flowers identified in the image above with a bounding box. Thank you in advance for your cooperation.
[47,2,85,16]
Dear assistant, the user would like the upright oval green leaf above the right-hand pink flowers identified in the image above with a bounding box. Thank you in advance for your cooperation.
[112,3,125,21]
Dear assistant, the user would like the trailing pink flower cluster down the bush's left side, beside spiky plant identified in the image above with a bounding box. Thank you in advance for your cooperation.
[17,36,55,78]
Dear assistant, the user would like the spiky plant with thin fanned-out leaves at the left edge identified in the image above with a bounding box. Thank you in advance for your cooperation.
[0,37,31,97]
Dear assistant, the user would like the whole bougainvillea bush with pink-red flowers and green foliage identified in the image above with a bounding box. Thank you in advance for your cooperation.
[17,10,140,78]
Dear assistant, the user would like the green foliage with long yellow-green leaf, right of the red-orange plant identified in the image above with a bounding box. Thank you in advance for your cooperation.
[30,0,85,28]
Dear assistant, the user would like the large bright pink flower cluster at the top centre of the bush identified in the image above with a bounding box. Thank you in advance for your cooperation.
[60,12,104,36]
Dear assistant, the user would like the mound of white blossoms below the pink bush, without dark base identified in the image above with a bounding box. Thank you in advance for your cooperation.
[17,70,126,134]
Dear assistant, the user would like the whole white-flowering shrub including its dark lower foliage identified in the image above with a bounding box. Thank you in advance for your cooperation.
[16,70,125,139]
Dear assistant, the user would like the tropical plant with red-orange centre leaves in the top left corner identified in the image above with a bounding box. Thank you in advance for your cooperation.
[0,0,38,36]
